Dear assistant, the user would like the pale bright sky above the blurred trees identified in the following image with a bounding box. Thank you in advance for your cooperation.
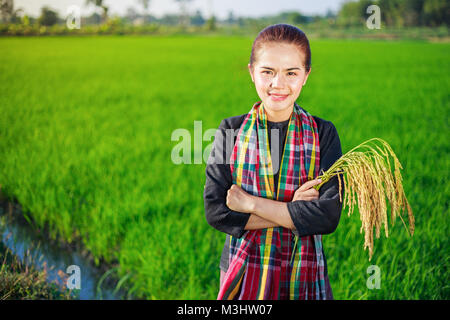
[14,0,345,19]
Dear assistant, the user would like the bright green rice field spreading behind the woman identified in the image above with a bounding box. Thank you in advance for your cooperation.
[0,34,450,299]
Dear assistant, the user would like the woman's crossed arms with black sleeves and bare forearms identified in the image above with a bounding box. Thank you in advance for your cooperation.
[203,118,342,237]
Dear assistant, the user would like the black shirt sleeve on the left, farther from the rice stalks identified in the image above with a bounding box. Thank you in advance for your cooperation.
[203,120,250,238]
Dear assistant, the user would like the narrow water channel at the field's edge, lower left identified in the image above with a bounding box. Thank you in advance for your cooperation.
[0,199,132,300]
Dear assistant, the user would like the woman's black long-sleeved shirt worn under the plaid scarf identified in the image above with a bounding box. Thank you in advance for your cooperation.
[203,114,344,274]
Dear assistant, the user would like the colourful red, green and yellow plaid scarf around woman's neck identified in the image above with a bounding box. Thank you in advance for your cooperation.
[218,101,329,300]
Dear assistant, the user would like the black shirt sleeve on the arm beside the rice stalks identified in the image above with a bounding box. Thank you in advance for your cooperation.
[287,121,344,237]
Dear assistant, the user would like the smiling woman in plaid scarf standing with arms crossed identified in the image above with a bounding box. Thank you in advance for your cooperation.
[204,24,342,300]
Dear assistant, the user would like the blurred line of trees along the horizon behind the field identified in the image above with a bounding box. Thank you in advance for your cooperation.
[0,0,450,28]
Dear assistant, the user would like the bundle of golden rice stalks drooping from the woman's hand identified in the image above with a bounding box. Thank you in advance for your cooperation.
[314,138,414,261]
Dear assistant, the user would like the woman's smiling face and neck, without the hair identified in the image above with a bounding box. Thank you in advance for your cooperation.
[248,43,311,122]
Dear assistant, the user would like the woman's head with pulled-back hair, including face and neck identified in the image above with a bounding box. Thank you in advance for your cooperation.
[248,24,311,121]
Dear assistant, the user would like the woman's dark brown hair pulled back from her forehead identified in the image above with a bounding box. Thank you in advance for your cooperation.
[250,23,311,72]
